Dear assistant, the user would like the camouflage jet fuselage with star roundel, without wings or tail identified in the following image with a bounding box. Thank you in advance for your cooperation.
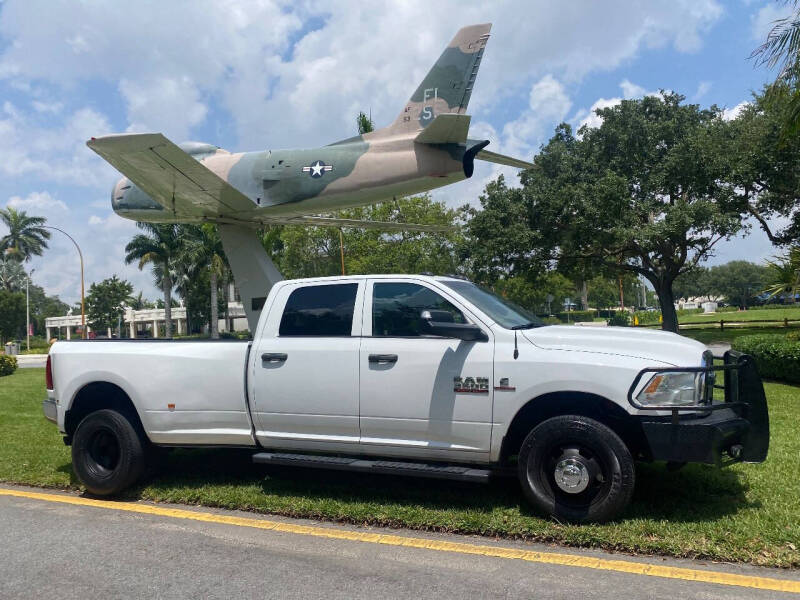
[112,134,471,223]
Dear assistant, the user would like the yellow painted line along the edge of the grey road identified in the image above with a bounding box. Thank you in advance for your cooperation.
[0,488,800,594]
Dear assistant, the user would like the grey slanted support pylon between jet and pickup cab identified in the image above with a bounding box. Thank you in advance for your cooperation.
[219,223,283,335]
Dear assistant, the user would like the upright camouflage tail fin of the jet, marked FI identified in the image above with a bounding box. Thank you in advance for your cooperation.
[389,23,492,133]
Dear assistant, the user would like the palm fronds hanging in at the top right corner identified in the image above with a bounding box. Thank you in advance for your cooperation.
[751,0,800,139]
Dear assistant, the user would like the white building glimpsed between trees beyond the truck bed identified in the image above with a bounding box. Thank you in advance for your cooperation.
[45,285,247,340]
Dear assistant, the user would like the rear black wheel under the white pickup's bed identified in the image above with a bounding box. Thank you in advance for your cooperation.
[72,410,145,496]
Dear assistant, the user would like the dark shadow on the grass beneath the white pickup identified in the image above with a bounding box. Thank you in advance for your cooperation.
[119,449,759,522]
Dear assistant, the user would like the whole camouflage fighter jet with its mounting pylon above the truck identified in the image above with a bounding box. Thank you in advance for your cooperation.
[87,23,532,323]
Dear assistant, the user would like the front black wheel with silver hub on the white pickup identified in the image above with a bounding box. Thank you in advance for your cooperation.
[518,415,636,523]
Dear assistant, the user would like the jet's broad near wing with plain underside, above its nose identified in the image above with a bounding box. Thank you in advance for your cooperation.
[86,133,255,217]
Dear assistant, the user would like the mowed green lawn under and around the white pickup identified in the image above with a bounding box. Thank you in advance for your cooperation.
[0,369,800,567]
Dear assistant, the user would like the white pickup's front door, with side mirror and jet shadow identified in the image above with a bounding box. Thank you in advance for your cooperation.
[359,279,494,458]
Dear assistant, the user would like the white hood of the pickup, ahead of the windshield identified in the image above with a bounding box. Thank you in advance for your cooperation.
[521,325,706,367]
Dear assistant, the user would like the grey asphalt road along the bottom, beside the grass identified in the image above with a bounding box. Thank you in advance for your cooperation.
[0,487,800,600]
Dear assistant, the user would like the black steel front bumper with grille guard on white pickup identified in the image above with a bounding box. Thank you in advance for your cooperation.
[628,350,769,466]
